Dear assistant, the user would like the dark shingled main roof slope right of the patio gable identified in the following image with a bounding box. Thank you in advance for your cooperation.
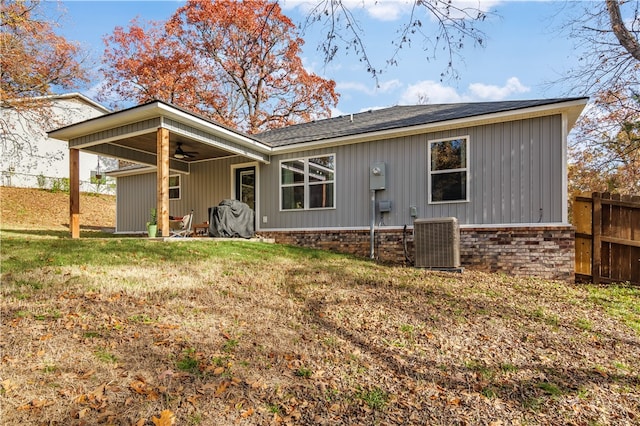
[253,98,585,147]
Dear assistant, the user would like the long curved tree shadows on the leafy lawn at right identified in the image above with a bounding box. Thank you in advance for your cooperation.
[289,269,640,420]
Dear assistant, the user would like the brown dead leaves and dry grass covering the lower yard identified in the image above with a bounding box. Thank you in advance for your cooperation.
[0,260,640,426]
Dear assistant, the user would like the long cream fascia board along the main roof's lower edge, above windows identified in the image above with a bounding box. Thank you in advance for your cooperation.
[273,99,588,154]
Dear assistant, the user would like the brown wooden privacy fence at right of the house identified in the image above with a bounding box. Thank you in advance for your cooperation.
[573,192,640,285]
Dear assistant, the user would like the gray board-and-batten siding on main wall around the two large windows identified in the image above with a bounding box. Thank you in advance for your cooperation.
[259,114,564,230]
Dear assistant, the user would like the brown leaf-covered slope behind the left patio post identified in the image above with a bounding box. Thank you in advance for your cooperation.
[0,186,116,230]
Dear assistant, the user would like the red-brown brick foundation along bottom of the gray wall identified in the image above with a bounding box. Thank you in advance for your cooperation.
[259,226,575,282]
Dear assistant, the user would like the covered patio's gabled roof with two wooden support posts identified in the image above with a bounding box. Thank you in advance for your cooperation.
[48,101,271,238]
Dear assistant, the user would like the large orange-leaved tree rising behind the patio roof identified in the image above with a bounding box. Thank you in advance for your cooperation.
[101,0,338,133]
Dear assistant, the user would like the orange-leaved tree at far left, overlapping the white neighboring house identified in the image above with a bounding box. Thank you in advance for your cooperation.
[0,0,88,161]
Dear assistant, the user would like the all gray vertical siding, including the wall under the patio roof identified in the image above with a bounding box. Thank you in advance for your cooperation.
[117,114,564,232]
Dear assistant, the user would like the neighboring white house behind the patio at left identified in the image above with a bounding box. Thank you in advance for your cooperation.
[0,93,113,192]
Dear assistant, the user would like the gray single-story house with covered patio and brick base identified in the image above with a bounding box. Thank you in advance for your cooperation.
[49,98,588,280]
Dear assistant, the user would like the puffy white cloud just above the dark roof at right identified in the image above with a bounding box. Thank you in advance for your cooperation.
[399,77,531,105]
